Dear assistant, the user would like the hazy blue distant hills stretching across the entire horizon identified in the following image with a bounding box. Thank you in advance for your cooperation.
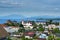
[0,14,60,20]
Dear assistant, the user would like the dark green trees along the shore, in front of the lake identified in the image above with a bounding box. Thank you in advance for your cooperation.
[4,20,59,26]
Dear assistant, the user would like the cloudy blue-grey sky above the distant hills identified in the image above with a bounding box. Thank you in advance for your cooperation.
[0,0,60,17]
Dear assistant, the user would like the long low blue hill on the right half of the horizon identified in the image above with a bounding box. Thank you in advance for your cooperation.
[28,15,60,20]
